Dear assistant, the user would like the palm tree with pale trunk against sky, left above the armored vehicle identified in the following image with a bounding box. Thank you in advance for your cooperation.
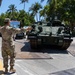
[29,2,42,21]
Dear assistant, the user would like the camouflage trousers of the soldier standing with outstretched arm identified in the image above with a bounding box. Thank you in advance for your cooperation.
[2,46,16,68]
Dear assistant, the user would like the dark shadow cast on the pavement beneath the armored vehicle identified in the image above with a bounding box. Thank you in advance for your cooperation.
[21,42,68,54]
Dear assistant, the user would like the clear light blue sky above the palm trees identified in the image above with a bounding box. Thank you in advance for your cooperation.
[0,0,46,14]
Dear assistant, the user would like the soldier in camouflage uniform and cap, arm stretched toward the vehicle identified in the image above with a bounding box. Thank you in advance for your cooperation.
[0,18,25,73]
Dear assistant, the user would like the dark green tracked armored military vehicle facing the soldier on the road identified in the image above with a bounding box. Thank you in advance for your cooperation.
[28,20,72,50]
